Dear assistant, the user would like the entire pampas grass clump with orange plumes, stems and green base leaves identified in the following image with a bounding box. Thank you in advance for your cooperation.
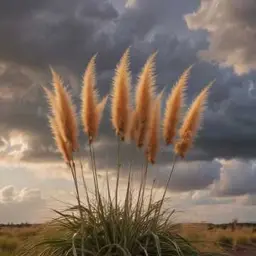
[21,49,218,256]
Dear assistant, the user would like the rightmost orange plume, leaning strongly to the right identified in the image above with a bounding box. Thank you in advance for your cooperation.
[174,82,213,158]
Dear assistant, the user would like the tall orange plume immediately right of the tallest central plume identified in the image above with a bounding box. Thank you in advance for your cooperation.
[135,52,157,148]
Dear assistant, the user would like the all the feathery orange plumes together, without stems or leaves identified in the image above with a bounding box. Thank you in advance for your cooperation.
[44,48,211,164]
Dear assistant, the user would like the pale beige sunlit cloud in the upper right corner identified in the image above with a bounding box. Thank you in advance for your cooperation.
[185,0,256,75]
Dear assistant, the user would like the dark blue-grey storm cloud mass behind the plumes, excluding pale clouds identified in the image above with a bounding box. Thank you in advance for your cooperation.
[0,0,256,196]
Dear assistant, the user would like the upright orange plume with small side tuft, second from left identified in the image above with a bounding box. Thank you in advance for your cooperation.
[81,55,107,144]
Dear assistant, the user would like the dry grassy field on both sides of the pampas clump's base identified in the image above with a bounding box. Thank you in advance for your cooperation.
[0,224,256,256]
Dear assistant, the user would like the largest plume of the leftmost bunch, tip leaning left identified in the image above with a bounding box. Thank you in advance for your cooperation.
[51,68,78,151]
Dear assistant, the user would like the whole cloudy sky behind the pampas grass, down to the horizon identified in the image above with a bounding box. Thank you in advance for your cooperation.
[0,0,256,222]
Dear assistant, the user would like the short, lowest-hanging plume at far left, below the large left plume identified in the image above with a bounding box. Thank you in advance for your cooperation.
[48,116,72,163]
